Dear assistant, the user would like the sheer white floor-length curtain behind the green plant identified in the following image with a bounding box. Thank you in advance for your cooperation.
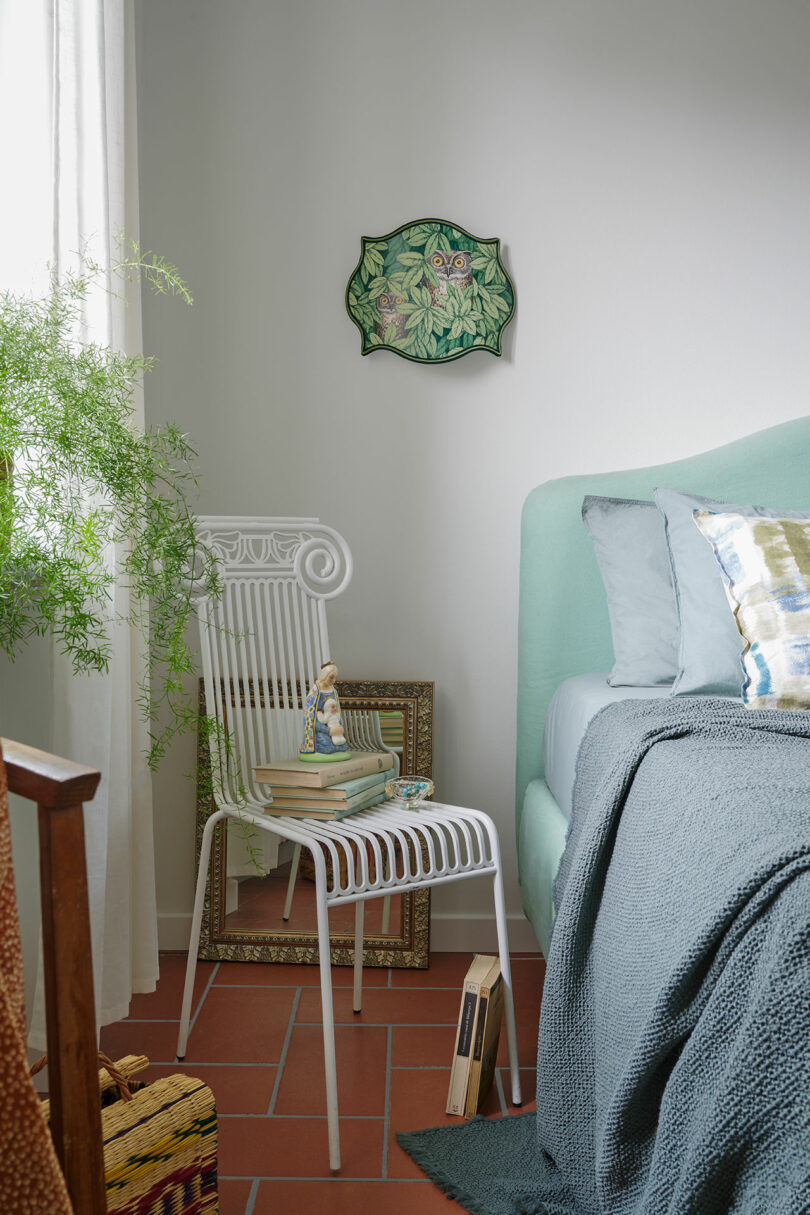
[0,0,158,1049]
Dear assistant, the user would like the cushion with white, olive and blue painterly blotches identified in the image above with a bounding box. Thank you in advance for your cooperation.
[693,510,810,708]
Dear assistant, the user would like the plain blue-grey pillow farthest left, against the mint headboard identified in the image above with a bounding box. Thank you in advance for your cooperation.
[582,495,680,688]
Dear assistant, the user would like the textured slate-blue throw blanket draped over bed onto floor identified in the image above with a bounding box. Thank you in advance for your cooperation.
[398,697,810,1215]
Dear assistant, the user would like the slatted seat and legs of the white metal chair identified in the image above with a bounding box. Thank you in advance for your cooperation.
[177,801,521,1170]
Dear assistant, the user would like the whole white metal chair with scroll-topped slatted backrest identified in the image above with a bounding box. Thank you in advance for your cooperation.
[177,516,521,1170]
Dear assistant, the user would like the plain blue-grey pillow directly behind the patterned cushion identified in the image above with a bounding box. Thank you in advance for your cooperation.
[655,490,808,696]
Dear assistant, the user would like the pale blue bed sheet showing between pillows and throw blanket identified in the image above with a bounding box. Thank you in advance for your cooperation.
[543,674,670,819]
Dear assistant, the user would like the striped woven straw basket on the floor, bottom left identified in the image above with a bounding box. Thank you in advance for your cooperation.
[44,1055,219,1215]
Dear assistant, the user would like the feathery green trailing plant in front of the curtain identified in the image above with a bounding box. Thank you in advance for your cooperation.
[0,245,217,767]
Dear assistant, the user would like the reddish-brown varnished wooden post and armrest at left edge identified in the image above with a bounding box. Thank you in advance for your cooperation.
[2,739,107,1215]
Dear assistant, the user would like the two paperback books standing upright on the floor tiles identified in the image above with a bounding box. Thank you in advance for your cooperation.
[446,954,504,1118]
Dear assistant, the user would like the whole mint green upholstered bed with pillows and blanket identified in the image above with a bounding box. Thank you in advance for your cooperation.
[407,419,810,1215]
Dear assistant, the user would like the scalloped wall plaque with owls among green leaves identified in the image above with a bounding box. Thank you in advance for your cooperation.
[346,220,515,363]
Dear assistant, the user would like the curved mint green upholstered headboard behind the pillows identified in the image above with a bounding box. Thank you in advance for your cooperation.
[516,418,810,840]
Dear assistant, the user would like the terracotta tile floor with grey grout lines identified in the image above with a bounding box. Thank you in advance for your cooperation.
[101,954,544,1215]
